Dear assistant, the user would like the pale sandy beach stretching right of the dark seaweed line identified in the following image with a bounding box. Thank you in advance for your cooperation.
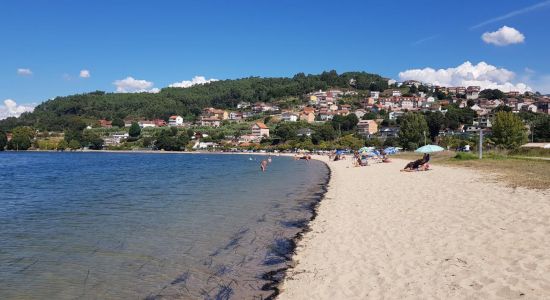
[278,157,550,299]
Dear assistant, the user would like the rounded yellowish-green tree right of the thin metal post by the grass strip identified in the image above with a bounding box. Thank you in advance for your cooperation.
[493,111,527,149]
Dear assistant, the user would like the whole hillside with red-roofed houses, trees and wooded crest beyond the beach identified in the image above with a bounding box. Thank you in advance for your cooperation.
[0,71,550,151]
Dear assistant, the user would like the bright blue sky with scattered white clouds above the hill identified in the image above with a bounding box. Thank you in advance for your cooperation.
[0,0,550,119]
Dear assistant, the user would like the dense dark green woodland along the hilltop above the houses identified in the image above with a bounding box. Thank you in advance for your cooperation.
[0,71,387,130]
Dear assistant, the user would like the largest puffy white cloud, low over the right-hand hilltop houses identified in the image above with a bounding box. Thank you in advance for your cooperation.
[399,61,532,93]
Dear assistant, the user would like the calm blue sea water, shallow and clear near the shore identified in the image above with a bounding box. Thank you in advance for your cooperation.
[0,152,328,299]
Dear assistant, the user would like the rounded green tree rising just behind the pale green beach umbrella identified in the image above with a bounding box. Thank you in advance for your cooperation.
[399,112,429,150]
